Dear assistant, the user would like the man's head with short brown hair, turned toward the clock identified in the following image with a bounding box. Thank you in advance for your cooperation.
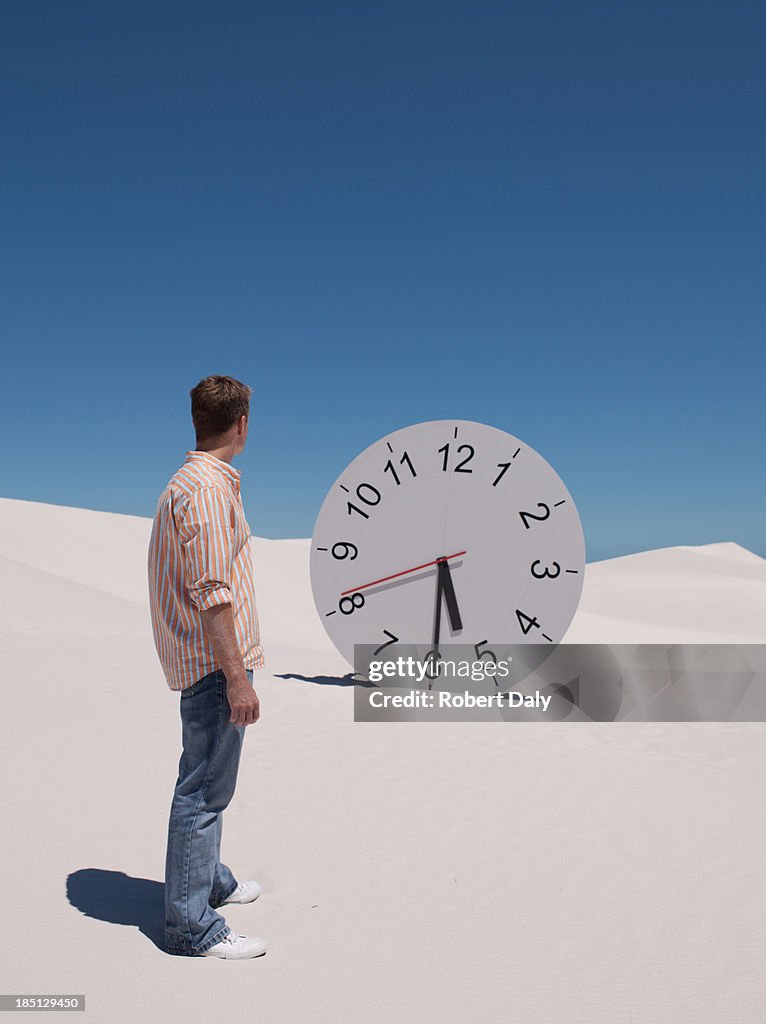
[189,375,253,455]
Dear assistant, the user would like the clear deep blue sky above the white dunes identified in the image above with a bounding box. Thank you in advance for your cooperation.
[0,0,766,560]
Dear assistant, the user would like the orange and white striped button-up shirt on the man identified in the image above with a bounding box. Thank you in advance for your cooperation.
[147,452,265,690]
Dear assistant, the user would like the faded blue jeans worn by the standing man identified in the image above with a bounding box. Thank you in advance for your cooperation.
[165,669,253,956]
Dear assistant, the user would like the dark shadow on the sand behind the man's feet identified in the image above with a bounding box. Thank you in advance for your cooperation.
[67,867,167,953]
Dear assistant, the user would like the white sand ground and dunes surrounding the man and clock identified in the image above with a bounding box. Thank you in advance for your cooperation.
[0,499,766,1024]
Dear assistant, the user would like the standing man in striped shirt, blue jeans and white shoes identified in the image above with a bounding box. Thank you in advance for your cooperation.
[148,376,266,959]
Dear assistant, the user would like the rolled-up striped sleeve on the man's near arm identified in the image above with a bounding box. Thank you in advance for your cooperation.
[179,486,233,611]
